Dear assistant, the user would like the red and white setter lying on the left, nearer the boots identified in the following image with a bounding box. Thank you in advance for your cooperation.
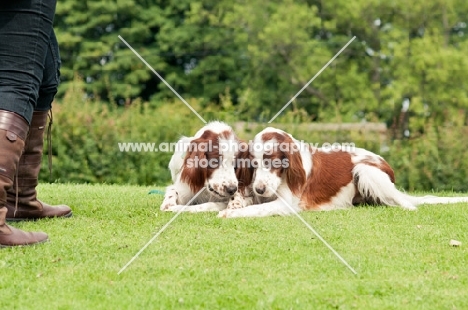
[160,121,251,212]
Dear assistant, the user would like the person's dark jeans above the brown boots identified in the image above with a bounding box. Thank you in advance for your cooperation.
[0,0,60,123]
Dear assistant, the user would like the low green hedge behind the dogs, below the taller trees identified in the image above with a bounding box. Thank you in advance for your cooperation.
[41,82,468,191]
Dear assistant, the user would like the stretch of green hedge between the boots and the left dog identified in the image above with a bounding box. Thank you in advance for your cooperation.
[41,80,201,184]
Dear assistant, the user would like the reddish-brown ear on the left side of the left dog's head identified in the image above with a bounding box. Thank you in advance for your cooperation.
[180,139,207,192]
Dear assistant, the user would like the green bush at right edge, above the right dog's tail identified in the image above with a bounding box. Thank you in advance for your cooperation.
[385,115,468,191]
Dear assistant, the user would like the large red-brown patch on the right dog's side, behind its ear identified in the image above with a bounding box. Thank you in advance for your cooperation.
[301,151,354,210]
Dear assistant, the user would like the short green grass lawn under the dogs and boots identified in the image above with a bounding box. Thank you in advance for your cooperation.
[0,184,468,309]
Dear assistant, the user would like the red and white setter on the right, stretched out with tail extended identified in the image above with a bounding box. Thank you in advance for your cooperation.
[218,127,468,217]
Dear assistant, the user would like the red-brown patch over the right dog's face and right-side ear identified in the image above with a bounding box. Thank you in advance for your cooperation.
[262,132,306,197]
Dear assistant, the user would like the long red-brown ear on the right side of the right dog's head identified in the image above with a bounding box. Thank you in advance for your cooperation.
[285,140,306,197]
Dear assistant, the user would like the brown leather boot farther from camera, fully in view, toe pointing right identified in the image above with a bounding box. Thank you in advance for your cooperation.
[6,111,72,221]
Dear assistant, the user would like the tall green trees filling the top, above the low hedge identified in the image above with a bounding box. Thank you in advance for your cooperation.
[56,0,468,125]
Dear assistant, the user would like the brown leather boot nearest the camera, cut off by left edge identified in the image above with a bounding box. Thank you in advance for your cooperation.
[0,110,48,248]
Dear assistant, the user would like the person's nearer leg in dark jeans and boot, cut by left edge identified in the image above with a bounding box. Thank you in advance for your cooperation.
[0,0,56,246]
